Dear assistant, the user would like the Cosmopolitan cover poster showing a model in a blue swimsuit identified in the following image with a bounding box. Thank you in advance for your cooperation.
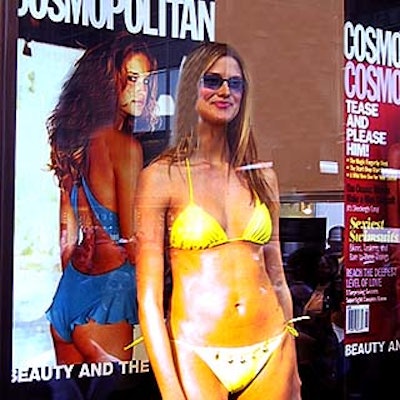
[10,0,215,399]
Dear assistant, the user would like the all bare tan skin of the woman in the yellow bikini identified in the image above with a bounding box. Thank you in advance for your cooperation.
[135,57,300,400]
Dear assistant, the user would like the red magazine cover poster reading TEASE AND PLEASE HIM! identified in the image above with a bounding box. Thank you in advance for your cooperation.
[344,21,400,356]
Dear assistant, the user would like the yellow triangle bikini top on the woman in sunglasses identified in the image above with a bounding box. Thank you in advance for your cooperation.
[169,159,272,250]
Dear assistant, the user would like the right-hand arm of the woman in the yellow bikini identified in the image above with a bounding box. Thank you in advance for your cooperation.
[264,168,293,321]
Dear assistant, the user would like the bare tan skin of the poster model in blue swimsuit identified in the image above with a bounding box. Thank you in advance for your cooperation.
[51,53,150,364]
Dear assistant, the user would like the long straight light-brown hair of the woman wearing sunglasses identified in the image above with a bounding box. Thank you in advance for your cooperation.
[161,42,272,205]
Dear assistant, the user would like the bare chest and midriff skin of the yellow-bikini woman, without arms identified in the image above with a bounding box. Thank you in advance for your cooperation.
[168,164,285,346]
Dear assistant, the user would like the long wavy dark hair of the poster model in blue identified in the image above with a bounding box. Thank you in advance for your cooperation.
[47,34,157,186]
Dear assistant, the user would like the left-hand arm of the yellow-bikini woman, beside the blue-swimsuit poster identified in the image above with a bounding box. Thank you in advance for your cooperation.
[135,163,185,400]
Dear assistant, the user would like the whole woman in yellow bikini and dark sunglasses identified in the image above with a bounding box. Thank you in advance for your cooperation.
[135,43,300,400]
